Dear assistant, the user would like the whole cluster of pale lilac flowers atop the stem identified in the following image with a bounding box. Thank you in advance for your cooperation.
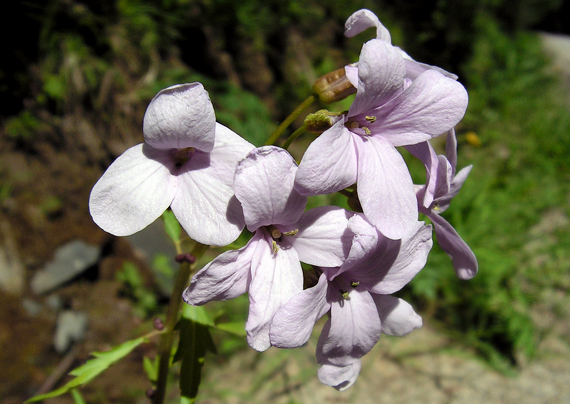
[90,10,477,390]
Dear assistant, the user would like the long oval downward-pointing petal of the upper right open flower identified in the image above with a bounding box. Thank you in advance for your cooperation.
[355,136,418,240]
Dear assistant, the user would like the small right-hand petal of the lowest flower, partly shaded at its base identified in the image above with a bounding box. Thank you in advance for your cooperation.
[372,294,423,337]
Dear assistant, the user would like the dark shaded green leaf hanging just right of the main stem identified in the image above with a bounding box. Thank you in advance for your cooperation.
[173,318,216,403]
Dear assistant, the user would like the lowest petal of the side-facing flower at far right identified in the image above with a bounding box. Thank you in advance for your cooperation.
[428,213,479,279]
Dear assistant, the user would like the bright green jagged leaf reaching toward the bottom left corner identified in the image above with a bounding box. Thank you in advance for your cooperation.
[26,337,148,403]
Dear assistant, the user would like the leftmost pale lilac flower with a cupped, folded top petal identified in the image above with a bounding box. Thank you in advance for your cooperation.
[89,83,254,246]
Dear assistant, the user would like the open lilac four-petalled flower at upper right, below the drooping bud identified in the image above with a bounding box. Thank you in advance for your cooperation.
[295,39,467,239]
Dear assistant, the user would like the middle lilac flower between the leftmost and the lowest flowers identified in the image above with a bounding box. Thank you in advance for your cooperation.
[183,146,352,351]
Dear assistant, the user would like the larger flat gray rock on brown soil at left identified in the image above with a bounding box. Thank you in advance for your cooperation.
[31,240,100,294]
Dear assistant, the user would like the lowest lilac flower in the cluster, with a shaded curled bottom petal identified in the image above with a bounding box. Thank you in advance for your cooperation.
[270,214,432,390]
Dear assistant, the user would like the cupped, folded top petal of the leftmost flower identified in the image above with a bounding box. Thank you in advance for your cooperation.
[143,83,216,152]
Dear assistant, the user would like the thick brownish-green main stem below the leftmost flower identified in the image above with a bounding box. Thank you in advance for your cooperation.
[152,243,208,404]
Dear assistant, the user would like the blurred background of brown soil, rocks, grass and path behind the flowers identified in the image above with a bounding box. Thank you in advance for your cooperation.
[0,0,570,404]
